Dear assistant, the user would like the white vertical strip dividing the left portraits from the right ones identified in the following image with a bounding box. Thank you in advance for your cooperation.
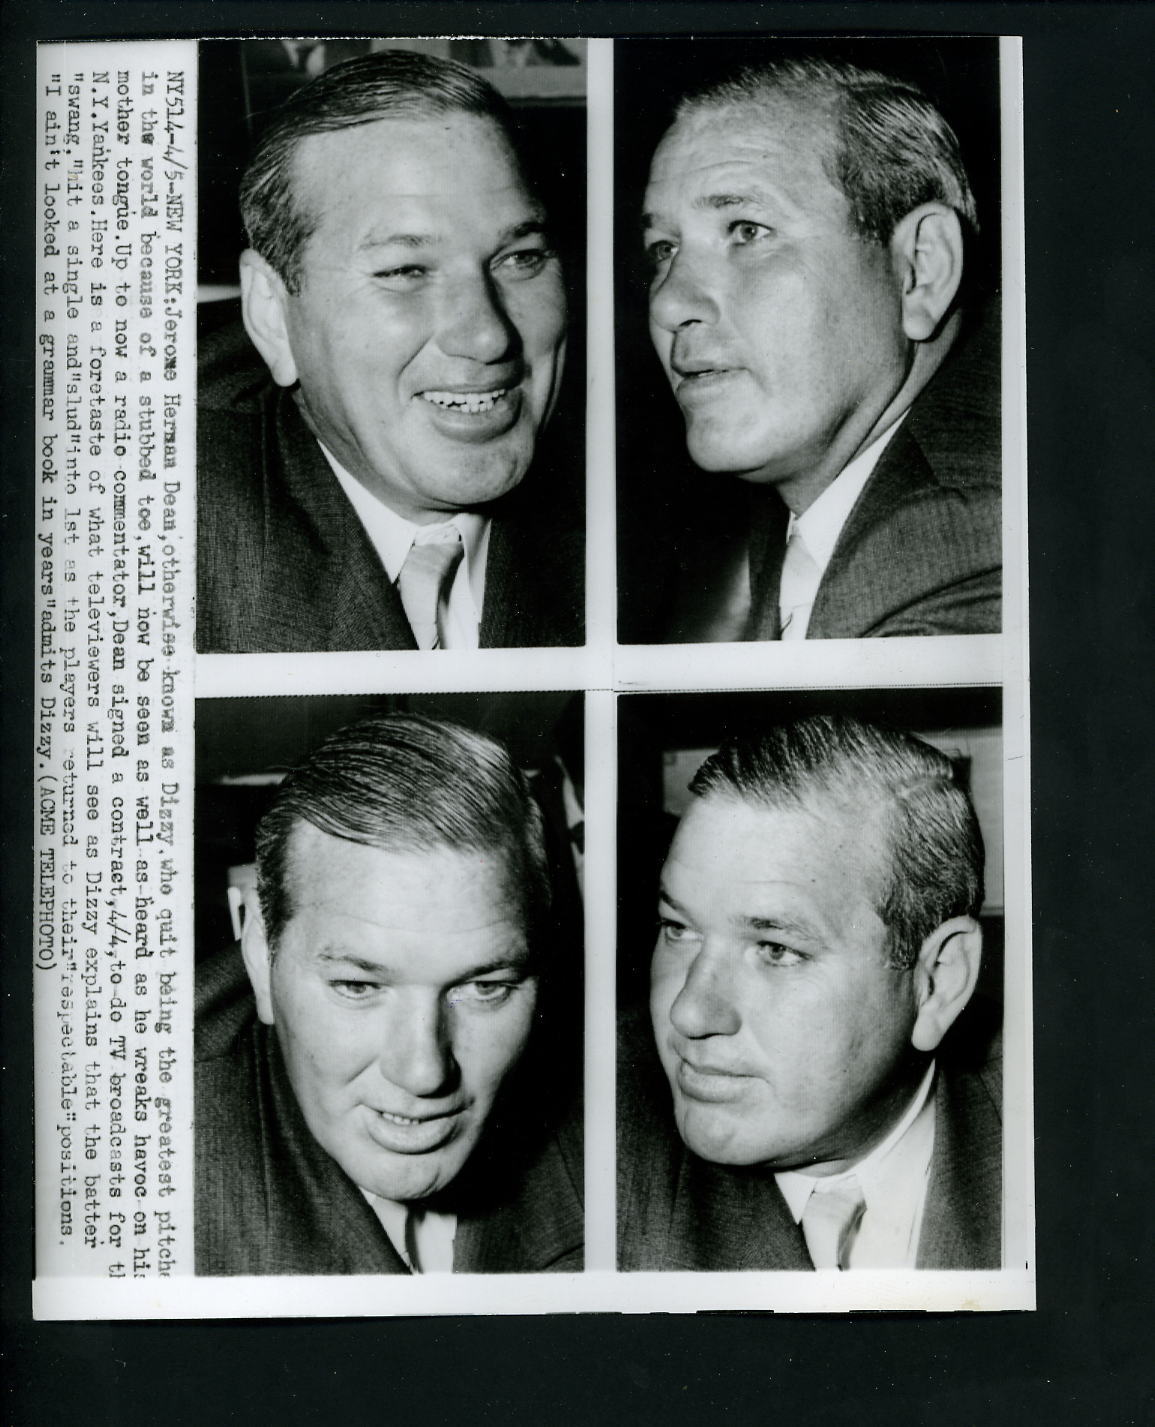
[585,40,617,1271]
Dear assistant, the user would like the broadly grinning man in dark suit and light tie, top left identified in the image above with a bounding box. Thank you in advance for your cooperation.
[197,50,582,652]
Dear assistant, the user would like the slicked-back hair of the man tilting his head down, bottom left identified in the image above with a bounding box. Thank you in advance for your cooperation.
[257,714,550,949]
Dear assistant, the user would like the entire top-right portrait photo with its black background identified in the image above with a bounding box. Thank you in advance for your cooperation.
[614,37,1018,644]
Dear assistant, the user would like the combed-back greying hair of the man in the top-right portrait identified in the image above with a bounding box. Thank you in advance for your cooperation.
[677,59,978,244]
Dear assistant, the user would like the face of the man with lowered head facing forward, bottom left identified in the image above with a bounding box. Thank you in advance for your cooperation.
[254,826,537,1200]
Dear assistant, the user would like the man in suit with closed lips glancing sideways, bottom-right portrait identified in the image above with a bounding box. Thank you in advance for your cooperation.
[618,716,1001,1270]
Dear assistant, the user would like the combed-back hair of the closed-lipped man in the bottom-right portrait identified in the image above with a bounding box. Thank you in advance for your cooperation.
[690,715,984,969]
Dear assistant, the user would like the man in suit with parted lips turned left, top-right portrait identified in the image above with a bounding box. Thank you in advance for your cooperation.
[642,59,1001,639]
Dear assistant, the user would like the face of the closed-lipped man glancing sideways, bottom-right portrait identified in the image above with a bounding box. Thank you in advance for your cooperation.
[650,795,915,1173]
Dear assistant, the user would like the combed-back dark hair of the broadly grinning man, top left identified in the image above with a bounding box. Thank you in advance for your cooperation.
[240,50,515,293]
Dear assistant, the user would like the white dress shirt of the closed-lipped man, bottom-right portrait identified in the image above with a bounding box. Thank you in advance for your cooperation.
[774,1065,935,1269]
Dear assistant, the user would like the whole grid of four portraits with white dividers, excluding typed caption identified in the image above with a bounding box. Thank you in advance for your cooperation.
[196,37,1034,1313]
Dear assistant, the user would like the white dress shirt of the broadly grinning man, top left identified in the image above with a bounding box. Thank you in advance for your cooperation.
[317,441,490,649]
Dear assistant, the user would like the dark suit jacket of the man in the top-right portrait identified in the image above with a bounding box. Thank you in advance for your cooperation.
[747,327,1002,639]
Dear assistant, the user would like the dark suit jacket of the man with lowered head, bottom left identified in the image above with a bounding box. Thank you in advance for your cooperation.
[196,948,582,1274]
